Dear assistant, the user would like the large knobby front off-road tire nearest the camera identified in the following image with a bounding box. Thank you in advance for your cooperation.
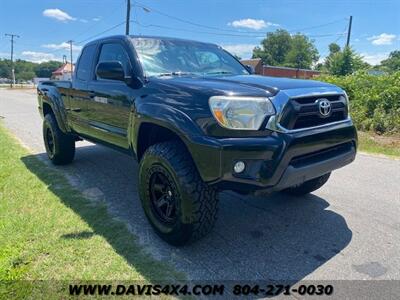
[139,141,218,246]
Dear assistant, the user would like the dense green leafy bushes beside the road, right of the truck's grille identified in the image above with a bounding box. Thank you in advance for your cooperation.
[317,72,400,134]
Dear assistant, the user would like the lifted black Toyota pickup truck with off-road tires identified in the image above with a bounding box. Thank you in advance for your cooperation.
[38,36,357,245]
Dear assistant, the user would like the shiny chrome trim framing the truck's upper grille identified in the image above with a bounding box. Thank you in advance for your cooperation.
[265,86,353,133]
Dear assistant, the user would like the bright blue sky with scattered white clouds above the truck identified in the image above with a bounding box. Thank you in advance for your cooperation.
[0,0,400,64]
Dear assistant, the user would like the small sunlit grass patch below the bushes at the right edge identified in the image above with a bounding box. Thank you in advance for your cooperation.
[358,131,400,158]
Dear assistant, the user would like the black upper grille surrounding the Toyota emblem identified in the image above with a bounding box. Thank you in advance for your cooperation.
[280,94,348,129]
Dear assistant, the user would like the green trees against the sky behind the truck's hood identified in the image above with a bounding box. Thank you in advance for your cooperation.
[252,29,400,76]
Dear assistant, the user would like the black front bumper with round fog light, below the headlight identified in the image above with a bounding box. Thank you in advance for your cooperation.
[188,120,357,193]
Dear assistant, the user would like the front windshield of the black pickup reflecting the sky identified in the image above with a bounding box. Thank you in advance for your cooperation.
[132,38,249,76]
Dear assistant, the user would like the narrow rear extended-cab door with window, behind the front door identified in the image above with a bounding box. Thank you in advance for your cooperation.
[66,44,97,134]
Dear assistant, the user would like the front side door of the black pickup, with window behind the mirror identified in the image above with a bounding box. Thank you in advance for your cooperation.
[88,40,137,149]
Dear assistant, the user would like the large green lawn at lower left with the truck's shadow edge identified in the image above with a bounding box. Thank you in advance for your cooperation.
[0,126,184,298]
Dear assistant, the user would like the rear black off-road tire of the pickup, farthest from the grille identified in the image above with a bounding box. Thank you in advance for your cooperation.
[43,114,75,165]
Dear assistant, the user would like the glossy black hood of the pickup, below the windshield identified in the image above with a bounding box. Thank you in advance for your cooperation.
[151,75,333,96]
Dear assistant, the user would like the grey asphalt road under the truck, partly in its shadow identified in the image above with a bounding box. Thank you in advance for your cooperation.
[0,90,400,288]
